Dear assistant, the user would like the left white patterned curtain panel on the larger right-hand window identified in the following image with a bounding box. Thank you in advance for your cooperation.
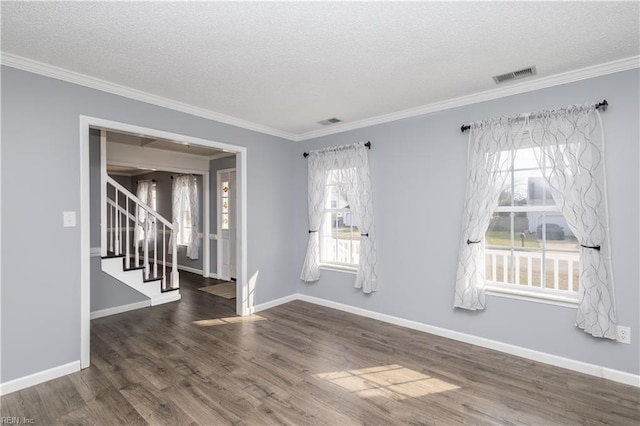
[454,116,525,310]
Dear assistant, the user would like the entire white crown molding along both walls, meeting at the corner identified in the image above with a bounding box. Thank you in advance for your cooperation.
[0,52,640,141]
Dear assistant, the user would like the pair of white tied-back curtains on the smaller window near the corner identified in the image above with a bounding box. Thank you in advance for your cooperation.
[300,142,378,293]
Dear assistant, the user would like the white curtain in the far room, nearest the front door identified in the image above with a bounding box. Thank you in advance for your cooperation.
[169,175,200,260]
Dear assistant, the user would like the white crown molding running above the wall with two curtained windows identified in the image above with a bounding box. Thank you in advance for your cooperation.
[295,56,640,141]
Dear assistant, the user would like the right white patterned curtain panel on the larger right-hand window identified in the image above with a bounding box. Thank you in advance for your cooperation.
[530,104,616,339]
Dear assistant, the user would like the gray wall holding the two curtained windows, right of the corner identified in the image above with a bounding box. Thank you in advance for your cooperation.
[296,70,640,374]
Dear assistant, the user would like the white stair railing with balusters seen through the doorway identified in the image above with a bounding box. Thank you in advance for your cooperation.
[102,175,180,291]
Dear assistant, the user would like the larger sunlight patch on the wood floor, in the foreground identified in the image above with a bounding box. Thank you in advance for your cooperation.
[315,364,459,400]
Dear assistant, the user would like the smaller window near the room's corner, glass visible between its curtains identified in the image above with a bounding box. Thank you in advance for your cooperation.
[319,170,360,268]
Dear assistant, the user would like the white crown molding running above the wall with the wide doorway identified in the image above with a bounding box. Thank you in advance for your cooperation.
[0,52,295,140]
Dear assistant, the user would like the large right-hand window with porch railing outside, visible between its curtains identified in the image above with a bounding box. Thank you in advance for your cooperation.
[485,145,580,298]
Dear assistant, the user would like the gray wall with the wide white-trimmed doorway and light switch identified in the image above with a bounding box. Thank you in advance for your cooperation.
[0,66,299,382]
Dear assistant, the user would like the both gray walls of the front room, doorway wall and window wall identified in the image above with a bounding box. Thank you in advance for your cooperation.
[0,63,640,382]
